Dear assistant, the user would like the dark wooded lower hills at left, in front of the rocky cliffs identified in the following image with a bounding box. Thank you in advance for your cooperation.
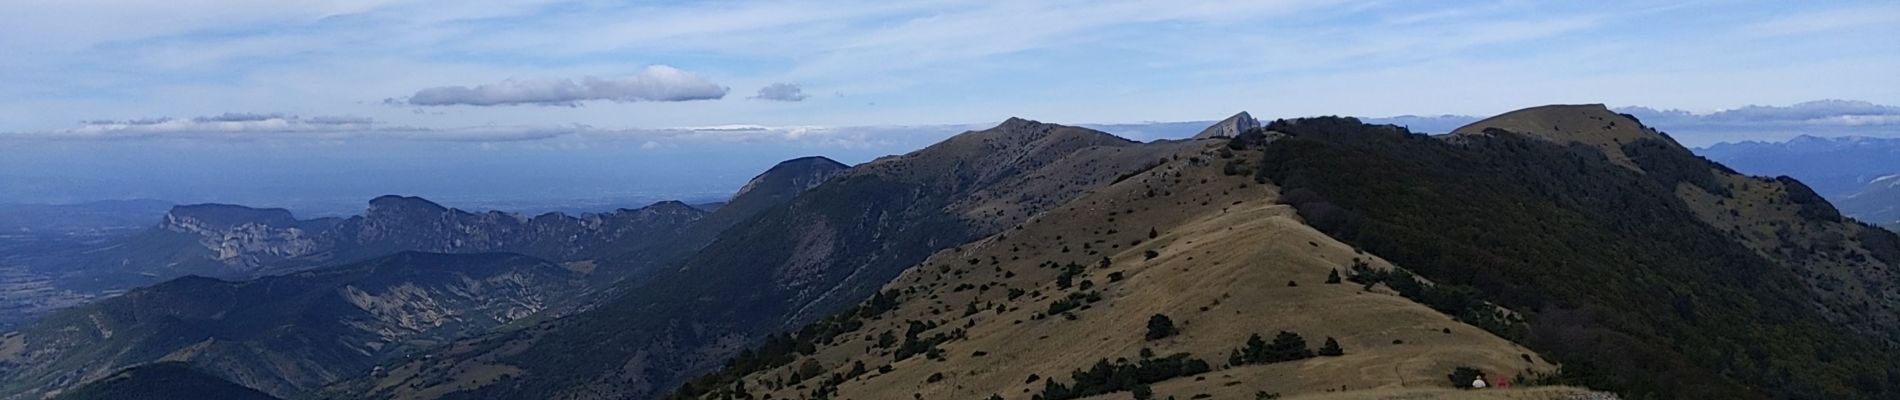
[0,252,585,398]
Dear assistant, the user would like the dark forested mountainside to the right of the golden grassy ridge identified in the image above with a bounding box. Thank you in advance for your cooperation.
[1262,108,1900,398]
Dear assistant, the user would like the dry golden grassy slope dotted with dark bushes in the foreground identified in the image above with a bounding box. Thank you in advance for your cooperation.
[747,142,1554,398]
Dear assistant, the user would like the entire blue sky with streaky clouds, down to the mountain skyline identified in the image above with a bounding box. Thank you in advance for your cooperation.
[0,0,1900,214]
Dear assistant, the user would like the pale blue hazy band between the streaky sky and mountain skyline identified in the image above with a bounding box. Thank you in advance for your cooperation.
[11,100,1900,216]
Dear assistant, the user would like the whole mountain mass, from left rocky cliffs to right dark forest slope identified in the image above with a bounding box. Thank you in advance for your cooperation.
[0,104,1900,400]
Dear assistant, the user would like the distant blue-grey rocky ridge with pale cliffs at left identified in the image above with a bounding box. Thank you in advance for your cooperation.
[125,195,707,279]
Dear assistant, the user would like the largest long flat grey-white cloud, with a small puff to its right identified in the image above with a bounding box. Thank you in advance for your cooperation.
[407,64,728,106]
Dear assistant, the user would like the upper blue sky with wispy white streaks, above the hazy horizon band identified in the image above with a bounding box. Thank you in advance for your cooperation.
[0,0,1900,133]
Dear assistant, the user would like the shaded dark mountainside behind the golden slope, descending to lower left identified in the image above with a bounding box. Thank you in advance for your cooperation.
[338,119,1182,398]
